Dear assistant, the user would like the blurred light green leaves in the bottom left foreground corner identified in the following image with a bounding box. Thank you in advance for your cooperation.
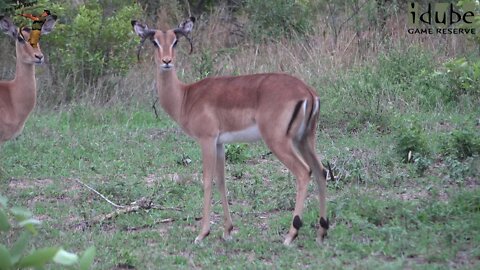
[0,195,95,270]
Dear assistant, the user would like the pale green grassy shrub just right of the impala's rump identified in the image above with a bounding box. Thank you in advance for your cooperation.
[328,47,444,132]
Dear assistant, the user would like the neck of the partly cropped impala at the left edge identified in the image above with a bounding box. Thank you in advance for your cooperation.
[11,44,37,116]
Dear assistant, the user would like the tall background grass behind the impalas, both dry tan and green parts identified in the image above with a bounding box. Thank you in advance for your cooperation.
[0,2,476,109]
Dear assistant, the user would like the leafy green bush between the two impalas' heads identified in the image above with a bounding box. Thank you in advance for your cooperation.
[45,1,141,102]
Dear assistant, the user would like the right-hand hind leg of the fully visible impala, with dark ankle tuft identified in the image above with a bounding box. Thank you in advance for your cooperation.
[298,130,329,242]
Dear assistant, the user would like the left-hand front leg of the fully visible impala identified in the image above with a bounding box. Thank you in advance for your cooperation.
[195,138,217,244]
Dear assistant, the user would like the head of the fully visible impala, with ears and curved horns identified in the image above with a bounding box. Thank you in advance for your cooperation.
[132,17,195,70]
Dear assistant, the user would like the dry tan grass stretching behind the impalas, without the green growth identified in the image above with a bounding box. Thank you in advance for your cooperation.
[0,4,475,107]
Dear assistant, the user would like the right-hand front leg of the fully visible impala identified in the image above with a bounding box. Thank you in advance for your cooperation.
[216,144,233,240]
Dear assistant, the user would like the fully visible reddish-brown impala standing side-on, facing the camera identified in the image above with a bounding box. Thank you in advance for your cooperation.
[132,17,328,245]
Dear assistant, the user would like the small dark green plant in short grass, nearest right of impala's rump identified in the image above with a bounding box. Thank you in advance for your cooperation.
[396,119,428,162]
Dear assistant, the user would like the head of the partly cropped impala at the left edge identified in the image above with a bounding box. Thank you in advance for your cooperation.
[0,15,57,64]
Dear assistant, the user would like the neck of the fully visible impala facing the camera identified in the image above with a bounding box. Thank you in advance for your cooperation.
[157,68,184,123]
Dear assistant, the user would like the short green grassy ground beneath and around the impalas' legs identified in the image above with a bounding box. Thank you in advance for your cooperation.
[0,103,480,269]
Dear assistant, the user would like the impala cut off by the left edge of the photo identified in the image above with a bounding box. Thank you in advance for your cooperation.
[0,15,56,144]
